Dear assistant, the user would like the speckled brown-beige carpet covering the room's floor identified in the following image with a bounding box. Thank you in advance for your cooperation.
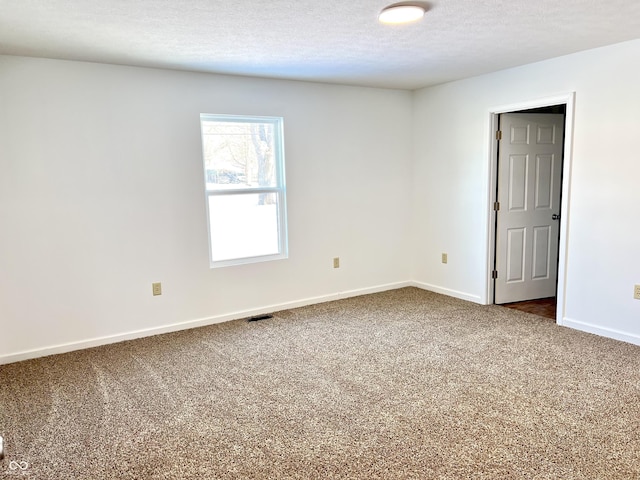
[0,288,640,480]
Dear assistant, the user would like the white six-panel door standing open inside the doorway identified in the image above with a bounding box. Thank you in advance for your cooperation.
[495,113,564,303]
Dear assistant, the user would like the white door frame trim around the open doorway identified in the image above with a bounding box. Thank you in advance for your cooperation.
[484,92,576,325]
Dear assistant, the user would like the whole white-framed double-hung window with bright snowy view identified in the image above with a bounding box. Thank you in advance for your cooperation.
[200,114,287,267]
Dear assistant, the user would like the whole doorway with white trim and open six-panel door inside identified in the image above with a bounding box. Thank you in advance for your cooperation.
[487,94,574,324]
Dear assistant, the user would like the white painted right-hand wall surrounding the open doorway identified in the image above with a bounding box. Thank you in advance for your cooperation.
[412,40,640,344]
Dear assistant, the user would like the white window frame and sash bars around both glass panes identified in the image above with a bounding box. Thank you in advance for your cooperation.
[200,113,289,268]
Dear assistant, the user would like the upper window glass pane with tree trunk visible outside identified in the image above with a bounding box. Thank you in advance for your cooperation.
[202,120,278,191]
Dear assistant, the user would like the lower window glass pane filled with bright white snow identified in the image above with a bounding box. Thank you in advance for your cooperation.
[209,193,280,262]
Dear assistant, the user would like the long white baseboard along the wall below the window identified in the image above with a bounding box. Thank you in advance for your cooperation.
[0,282,412,365]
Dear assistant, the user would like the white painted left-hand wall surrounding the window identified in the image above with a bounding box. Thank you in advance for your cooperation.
[0,57,412,363]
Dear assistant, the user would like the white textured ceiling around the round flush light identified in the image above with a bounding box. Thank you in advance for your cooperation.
[0,0,640,89]
